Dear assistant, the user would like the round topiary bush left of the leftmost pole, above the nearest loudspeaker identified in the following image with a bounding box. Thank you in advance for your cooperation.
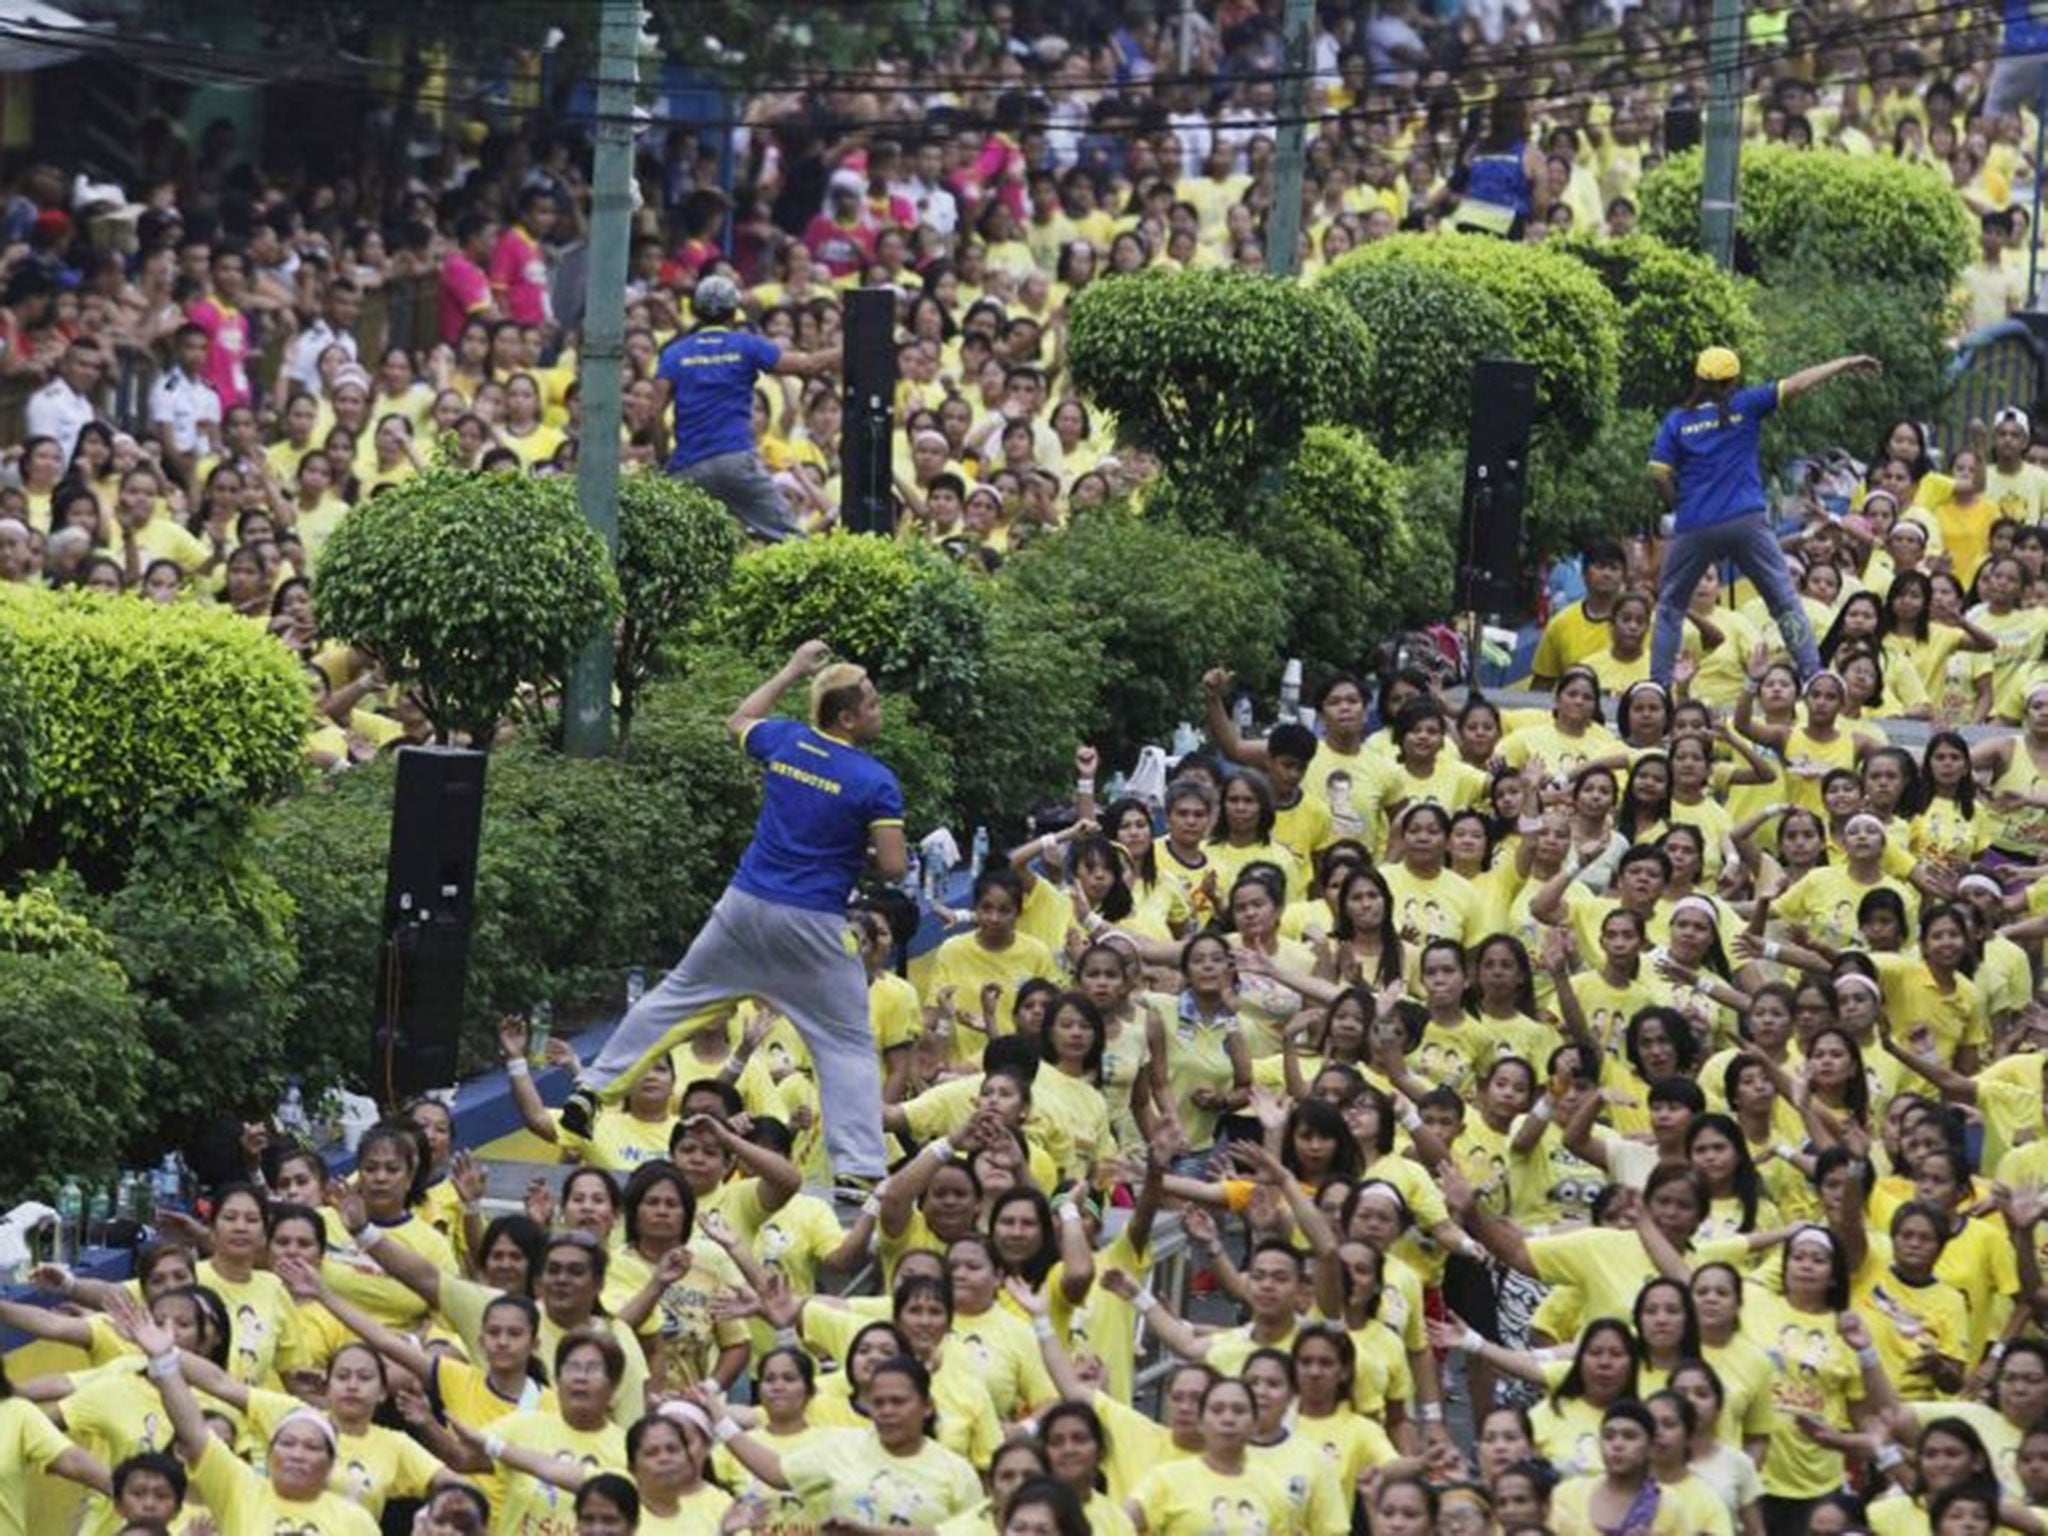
[313,469,621,748]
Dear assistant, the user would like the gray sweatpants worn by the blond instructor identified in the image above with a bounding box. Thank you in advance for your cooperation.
[582,887,889,1178]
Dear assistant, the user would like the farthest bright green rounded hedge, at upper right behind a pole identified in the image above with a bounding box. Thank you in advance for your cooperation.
[1640,143,1976,295]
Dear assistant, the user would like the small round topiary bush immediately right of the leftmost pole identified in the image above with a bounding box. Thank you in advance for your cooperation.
[616,475,745,737]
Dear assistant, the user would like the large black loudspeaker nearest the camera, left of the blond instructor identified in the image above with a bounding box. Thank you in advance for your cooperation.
[371,748,483,1108]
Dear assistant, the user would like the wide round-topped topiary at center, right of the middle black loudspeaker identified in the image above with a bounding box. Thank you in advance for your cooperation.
[1067,270,1376,477]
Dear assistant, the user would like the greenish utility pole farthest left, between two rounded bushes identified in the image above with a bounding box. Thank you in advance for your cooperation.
[563,0,641,758]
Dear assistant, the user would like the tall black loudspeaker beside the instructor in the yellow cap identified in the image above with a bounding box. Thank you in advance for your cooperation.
[1456,356,1536,614]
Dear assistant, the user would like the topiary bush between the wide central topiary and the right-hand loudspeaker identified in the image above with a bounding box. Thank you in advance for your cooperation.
[1319,262,1513,457]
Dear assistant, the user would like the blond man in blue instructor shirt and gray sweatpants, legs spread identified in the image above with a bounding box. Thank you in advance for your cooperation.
[561,641,907,1200]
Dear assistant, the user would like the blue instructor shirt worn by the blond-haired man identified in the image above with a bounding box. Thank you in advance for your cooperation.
[733,719,903,911]
